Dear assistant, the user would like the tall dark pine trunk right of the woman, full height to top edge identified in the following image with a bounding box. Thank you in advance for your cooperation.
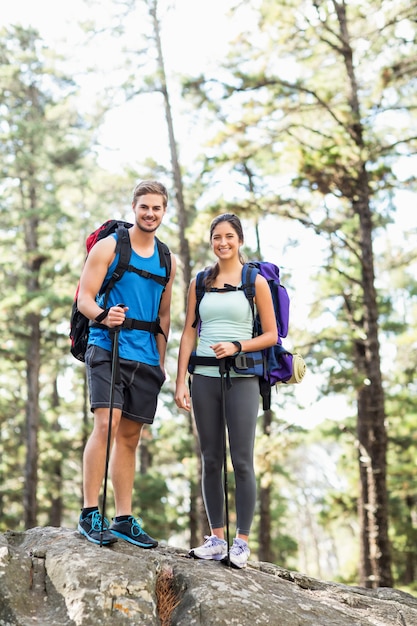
[333,0,393,587]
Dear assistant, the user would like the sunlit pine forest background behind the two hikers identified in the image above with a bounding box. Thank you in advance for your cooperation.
[0,0,417,592]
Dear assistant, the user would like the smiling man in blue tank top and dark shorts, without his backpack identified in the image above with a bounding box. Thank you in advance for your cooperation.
[78,181,176,548]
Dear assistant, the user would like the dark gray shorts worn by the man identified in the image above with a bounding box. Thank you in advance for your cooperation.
[85,345,165,424]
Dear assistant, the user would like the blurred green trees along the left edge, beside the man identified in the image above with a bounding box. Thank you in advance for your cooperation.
[0,27,97,529]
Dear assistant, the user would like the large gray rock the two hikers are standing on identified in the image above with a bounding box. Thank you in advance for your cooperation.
[0,527,417,626]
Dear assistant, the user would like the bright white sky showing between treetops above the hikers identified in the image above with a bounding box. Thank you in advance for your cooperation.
[0,0,239,169]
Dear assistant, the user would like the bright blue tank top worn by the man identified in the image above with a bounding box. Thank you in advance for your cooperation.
[88,234,165,365]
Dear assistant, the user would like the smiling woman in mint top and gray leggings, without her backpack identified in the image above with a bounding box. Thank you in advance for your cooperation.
[175,213,278,568]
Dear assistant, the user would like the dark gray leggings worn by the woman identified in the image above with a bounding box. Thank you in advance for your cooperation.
[191,374,259,535]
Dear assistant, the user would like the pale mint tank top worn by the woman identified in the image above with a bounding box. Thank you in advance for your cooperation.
[194,290,253,376]
